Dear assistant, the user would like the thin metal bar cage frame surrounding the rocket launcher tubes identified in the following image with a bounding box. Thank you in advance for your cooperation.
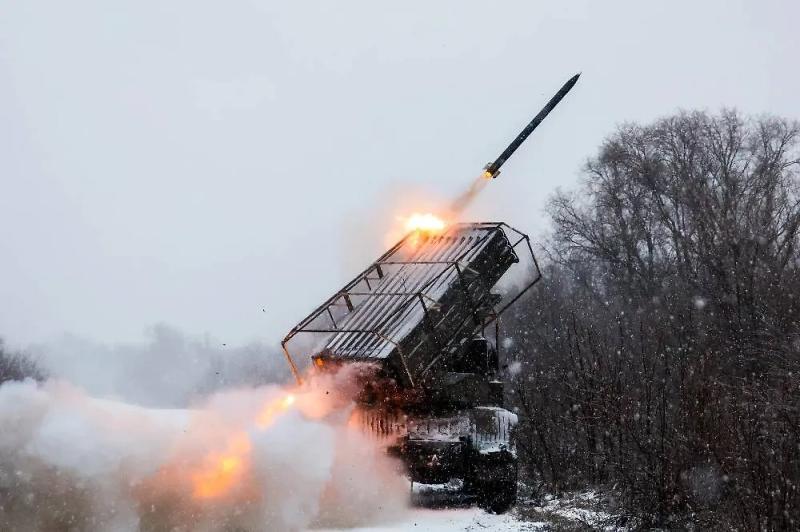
[281,222,542,386]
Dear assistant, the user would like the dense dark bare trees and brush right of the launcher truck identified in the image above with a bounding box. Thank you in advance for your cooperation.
[505,111,800,530]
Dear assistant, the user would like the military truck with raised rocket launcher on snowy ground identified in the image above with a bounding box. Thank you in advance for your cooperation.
[282,222,540,512]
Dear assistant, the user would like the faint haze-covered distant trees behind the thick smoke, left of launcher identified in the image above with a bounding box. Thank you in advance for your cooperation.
[31,324,291,407]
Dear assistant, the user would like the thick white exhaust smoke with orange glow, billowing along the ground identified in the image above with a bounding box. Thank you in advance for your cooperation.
[0,372,408,531]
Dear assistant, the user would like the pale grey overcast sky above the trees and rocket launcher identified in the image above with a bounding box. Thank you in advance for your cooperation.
[0,0,800,345]
